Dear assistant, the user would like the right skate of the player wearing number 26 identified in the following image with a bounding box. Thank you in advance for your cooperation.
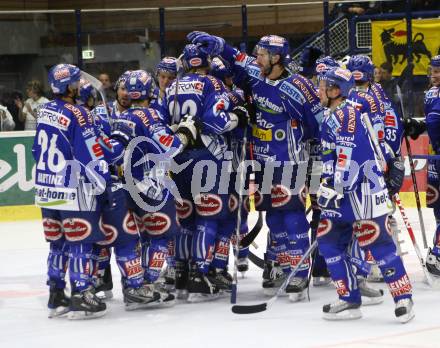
[68,287,107,320]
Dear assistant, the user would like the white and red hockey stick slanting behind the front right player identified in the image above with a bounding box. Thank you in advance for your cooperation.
[362,113,434,287]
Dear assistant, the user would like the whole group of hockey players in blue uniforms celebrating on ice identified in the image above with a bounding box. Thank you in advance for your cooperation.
[33,32,440,322]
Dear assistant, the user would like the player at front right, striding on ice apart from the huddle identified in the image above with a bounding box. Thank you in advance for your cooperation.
[317,68,414,322]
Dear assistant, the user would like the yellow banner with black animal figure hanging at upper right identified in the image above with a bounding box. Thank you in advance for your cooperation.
[371,19,440,76]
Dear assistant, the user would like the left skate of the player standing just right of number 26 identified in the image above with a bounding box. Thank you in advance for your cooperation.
[122,284,161,311]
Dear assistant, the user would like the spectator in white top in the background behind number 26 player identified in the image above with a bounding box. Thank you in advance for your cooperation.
[15,80,49,130]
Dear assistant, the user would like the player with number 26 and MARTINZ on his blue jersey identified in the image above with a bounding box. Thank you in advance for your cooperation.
[32,64,110,319]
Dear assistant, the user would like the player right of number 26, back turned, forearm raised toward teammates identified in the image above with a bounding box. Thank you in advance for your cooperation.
[104,70,200,309]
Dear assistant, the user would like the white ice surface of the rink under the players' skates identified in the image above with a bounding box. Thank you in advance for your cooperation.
[0,209,440,348]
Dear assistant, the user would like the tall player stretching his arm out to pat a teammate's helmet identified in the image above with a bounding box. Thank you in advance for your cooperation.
[188,32,323,302]
